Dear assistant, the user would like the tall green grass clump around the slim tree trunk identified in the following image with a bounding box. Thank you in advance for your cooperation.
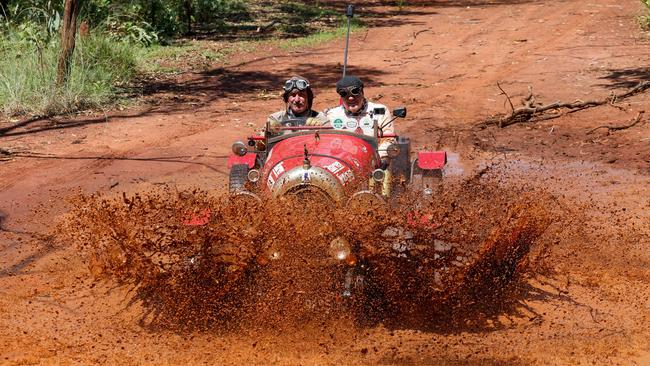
[0,24,138,116]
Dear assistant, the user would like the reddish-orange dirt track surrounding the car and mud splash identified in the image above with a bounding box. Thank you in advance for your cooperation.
[0,0,650,365]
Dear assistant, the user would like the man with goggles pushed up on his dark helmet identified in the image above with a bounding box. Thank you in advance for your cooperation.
[268,76,327,132]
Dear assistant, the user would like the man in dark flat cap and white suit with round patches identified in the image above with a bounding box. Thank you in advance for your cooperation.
[324,75,395,160]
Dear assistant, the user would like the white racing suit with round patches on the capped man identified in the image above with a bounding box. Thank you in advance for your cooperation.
[324,100,395,158]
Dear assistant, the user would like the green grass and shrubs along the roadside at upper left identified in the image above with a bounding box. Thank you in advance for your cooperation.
[0,0,361,121]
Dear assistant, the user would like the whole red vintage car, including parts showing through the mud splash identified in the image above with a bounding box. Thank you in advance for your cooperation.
[177,108,446,318]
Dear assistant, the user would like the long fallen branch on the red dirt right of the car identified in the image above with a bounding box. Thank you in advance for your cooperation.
[480,81,650,128]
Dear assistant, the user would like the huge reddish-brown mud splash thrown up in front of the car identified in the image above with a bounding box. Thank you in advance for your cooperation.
[57,179,558,330]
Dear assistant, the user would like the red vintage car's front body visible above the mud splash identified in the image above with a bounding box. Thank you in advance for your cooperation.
[228,108,447,206]
